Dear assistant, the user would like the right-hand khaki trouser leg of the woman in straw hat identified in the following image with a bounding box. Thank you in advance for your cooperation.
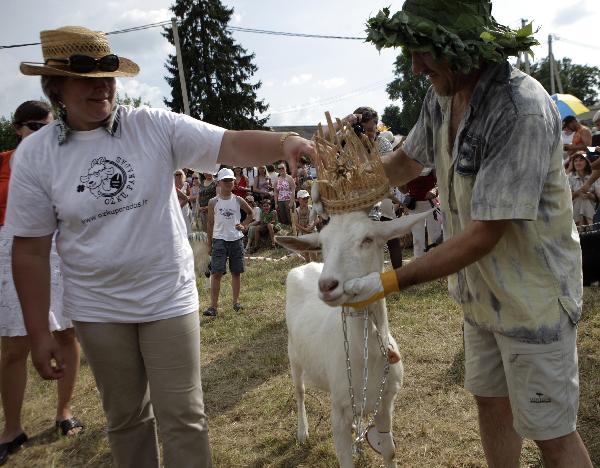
[138,313,212,468]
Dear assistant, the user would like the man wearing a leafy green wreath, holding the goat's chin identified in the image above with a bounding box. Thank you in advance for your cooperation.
[344,0,592,467]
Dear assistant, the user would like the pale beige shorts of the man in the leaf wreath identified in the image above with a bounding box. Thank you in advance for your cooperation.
[464,311,579,440]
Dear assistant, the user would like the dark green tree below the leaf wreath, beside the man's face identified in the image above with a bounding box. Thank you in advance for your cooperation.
[384,53,429,135]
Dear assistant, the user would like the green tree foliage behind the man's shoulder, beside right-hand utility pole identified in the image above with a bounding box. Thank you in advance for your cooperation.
[531,57,600,106]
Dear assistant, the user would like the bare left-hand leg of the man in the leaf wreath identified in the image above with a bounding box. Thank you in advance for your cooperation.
[475,396,522,468]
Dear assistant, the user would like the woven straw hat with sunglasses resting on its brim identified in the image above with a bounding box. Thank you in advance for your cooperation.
[20,26,140,78]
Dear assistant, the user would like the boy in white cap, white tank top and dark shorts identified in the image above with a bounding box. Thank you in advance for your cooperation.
[204,168,253,317]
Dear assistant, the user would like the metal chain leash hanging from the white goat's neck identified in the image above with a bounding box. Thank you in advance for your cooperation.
[342,307,390,454]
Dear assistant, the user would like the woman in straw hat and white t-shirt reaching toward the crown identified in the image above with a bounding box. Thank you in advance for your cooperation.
[6,27,312,467]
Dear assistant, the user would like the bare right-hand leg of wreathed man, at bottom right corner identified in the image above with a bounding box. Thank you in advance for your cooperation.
[535,431,592,468]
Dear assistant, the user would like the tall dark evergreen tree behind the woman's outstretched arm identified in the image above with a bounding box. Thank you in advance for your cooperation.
[163,0,268,130]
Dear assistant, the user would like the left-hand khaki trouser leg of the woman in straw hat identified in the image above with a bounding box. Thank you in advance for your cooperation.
[73,322,159,468]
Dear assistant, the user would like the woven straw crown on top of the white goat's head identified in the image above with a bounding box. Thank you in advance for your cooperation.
[313,112,389,214]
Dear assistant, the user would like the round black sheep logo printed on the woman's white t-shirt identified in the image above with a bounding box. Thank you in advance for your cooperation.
[77,156,135,205]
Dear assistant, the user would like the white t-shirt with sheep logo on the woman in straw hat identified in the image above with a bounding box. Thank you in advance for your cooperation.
[6,106,225,322]
